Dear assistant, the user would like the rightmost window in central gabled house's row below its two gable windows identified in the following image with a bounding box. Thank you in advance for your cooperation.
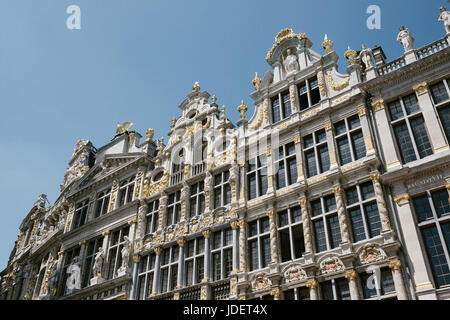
[334,115,366,166]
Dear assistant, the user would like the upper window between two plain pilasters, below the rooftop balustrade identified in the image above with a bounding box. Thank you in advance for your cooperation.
[387,94,433,163]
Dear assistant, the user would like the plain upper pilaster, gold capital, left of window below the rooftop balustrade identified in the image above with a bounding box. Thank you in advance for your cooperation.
[372,99,401,170]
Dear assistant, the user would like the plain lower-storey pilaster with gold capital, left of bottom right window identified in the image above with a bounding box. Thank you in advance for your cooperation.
[394,193,436,300]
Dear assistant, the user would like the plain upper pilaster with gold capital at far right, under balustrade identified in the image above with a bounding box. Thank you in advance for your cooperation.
[413,82,449,153]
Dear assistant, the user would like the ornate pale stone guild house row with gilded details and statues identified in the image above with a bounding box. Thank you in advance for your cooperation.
[0,8,450,300]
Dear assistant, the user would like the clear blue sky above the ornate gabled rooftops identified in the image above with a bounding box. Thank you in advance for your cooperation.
[0,0,450,269]
